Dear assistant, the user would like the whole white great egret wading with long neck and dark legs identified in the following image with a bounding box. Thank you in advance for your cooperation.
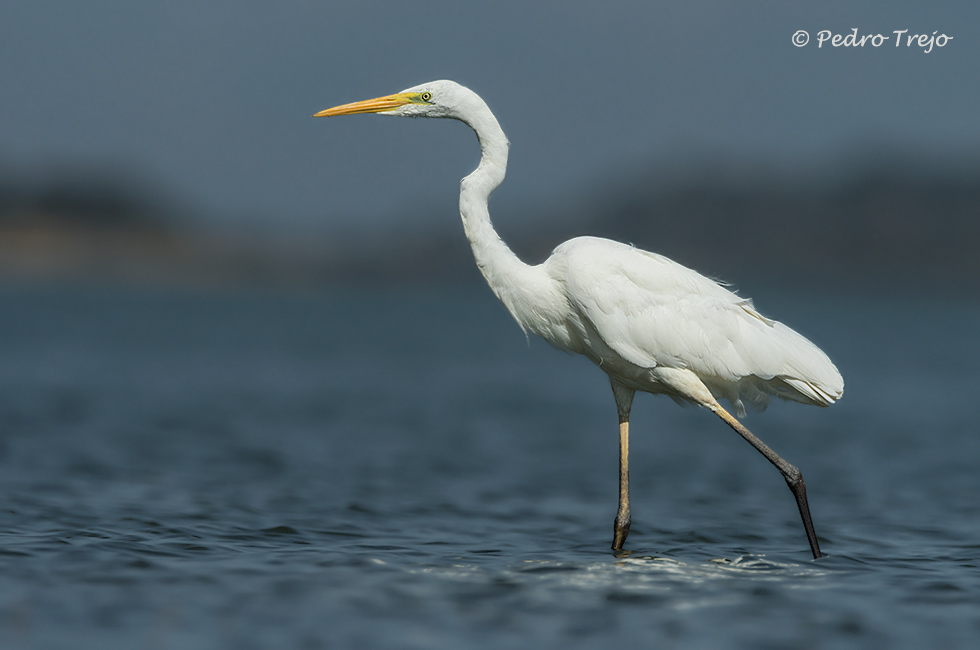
[314,81,844,558]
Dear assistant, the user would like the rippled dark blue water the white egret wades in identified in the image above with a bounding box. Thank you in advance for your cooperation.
[0,288,980,649]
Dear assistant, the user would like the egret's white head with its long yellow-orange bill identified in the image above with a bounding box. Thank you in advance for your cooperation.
[313,80,468,119]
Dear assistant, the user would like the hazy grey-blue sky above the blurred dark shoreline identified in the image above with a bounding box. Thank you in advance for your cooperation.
[0,0,980,233]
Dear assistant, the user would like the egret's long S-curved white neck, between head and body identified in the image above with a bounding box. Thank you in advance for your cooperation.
[459,101,541,330]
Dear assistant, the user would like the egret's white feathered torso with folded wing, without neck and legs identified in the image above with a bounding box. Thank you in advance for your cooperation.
[503,237,843,415]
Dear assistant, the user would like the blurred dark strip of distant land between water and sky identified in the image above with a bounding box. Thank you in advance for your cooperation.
[0,156,980,291]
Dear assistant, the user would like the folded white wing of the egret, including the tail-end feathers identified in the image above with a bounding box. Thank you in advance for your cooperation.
[556,238,843,410]
